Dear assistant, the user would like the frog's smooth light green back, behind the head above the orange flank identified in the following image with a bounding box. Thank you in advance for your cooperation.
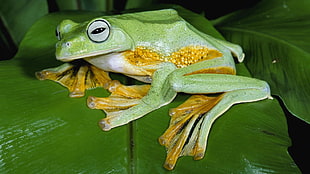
[105,9,218,55]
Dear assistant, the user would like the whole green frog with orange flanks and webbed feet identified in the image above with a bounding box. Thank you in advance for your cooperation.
[36,9,271,170]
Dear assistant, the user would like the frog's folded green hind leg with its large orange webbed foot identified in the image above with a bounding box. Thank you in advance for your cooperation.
[159,74,271,170]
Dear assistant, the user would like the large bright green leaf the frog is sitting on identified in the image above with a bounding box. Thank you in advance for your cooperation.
[0,8,300,174]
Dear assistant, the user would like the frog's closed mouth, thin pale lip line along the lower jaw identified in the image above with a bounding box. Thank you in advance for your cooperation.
[56,47,121,62]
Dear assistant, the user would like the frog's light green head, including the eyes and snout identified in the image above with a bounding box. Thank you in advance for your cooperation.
[56,18,132,62]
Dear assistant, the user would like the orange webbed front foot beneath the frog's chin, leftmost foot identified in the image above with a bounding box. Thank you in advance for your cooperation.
[36,61,111,97]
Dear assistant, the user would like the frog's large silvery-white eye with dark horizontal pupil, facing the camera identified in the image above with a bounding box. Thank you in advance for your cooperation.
[87,19,110,43]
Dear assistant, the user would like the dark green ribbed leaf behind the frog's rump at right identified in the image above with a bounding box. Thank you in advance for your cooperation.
[216,0,310,123]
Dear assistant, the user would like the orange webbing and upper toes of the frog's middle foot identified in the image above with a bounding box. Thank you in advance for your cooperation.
[87,80,150,119]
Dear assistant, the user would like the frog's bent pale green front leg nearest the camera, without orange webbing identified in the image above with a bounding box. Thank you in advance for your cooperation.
[88,63,177,131]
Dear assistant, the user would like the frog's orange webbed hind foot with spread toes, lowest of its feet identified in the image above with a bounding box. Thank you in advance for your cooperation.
[159,95,222,170]
